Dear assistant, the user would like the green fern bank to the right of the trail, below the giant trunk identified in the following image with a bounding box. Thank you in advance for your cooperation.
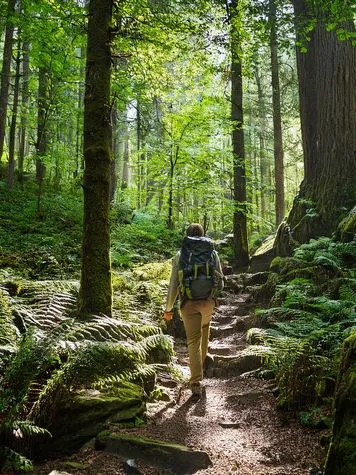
[249,238,356,412]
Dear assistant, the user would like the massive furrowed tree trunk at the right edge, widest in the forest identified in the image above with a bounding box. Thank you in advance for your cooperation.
[276,0,356,255]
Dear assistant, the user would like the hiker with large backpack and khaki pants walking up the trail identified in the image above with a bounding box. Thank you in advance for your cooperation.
[163,223,224,395]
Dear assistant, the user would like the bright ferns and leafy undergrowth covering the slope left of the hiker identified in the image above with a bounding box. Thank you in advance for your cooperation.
[0,183,180,471]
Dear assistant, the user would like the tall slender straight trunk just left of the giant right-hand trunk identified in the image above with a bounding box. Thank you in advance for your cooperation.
[269,0,285,226]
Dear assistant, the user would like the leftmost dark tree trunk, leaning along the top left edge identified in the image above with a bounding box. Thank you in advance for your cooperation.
[0,0,16,165]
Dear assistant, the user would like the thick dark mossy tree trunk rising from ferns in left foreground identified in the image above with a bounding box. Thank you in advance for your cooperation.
[79,0,113,315]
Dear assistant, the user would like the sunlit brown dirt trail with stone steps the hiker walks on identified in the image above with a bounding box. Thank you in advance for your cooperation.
[33,278,325,475]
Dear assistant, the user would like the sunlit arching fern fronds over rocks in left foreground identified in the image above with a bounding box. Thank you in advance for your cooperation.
[0,274,173,470]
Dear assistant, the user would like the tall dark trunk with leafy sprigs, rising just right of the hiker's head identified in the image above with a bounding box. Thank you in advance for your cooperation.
[229,1,249,269]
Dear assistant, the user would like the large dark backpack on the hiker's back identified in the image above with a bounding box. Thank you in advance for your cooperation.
[178,236,217,300]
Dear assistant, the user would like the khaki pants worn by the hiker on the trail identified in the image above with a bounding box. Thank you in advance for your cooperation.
[180,299,215,384]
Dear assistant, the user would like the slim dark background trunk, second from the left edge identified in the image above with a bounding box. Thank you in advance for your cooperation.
[18,42,30,186]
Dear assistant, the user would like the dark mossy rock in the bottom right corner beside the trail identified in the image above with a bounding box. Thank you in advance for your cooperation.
[324,331,356,475]
